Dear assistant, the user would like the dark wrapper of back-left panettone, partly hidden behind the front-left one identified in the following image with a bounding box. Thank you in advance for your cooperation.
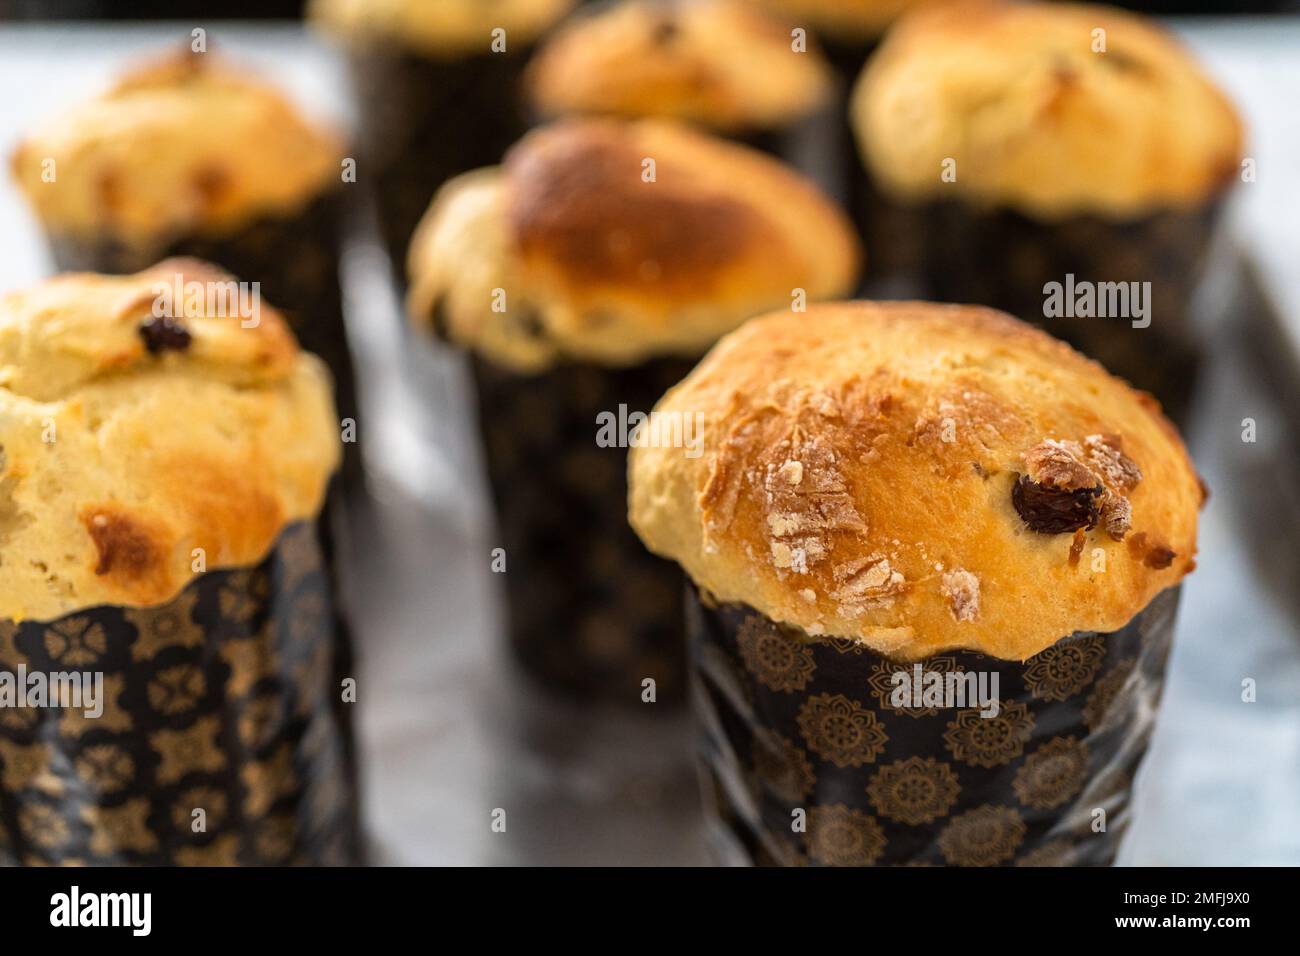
[48,190,361,492]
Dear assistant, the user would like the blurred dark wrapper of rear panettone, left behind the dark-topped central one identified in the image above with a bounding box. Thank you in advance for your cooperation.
[348,48,529,278]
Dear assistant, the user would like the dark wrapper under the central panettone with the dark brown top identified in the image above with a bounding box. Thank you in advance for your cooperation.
[473,358,694,705]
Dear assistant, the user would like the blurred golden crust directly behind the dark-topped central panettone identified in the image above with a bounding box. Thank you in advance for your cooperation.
[525,0,832,133]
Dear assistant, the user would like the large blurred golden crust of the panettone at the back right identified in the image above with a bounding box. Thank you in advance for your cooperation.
[852,0,1242,219]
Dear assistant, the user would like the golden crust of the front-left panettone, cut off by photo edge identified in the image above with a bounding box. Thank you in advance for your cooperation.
[0,259,339,620]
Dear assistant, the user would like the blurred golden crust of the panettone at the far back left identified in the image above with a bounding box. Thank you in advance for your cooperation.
[12,51,342,248]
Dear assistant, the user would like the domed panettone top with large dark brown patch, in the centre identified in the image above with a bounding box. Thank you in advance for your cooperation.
[408,120,861,372]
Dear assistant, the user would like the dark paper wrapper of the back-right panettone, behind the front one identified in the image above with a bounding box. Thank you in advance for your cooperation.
[897,202,1221,424]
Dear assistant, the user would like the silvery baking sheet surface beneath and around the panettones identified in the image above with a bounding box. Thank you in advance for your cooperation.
[0,21,1300,865]
